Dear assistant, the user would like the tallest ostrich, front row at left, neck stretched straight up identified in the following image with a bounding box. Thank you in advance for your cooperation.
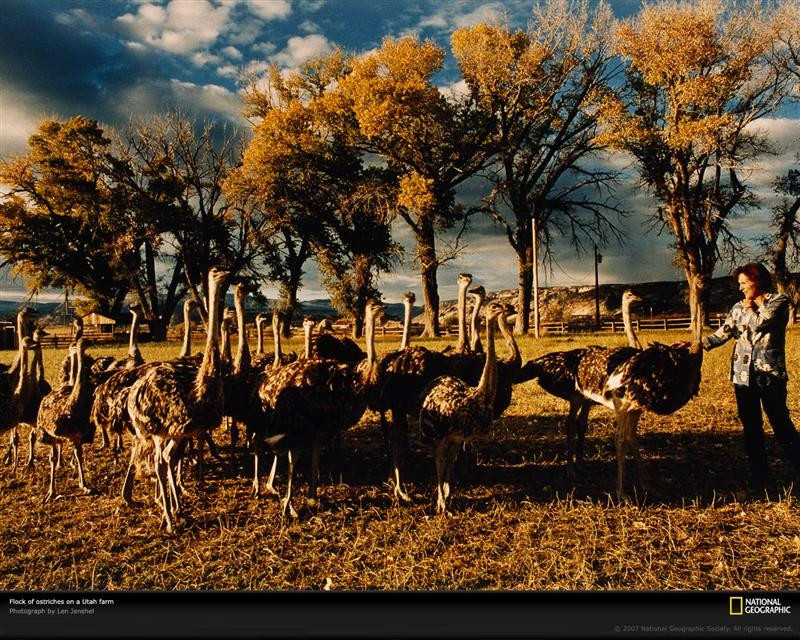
[128,267,228,533]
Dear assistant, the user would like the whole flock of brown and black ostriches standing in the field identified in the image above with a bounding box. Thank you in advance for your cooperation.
[0,269,702,532]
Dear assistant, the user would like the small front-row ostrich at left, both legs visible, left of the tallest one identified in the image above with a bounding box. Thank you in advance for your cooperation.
[36,338,94,502]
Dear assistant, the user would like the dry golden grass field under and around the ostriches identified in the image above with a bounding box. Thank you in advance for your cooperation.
[0,329,800,590]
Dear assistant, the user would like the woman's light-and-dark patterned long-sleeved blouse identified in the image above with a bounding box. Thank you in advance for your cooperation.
[703,293,789,386]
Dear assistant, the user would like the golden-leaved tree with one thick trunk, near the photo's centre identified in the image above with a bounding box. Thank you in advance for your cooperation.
[338,36,491,336]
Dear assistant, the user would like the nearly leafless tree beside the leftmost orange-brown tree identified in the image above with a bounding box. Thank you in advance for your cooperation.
[127,112,264,322]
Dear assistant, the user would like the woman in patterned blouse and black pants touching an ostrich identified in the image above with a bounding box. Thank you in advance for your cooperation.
[703,262,800,494]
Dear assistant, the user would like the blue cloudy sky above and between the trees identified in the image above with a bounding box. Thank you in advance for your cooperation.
[0,0,800,302]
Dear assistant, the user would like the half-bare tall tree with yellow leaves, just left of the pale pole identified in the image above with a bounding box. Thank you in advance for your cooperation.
[452,0,619,333]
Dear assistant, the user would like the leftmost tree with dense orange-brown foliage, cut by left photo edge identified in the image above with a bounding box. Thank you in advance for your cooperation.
[0,116,138,315]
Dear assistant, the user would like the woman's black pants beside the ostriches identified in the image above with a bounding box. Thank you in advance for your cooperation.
[733,370,800,487]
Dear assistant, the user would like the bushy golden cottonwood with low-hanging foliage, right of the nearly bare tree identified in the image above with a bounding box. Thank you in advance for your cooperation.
[236,51,397,335]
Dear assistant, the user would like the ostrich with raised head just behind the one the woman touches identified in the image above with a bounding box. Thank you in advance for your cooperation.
[516,290,641,480]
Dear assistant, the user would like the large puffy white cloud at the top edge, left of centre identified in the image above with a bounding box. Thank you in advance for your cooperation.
[116,0,232,55]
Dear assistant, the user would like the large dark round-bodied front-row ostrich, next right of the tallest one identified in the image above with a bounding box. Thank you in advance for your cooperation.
[259,300,382,517]
